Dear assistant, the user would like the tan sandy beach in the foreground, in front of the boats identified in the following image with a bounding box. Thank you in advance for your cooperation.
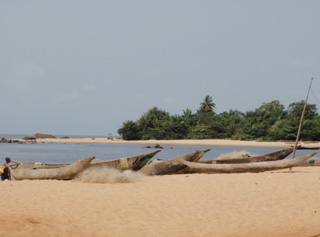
[0,167,320,237]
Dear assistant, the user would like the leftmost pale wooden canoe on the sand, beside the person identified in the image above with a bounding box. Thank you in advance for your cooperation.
[10,157,94,180]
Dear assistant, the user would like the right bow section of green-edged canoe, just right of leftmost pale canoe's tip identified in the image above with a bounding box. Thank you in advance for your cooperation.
[90,150,161,171]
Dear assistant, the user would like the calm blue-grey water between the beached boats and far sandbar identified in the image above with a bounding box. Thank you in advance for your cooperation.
[0,140,319,164]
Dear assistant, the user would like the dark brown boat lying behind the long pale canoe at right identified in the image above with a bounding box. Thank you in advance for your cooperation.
[199,147,293,164]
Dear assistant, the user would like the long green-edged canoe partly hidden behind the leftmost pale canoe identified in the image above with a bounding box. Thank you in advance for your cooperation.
[12,150,161,170]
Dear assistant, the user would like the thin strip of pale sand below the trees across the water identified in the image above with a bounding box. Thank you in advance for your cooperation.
[29,138,320,148]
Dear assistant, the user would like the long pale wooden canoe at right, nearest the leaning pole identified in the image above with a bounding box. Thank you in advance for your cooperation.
[179,153,317,174]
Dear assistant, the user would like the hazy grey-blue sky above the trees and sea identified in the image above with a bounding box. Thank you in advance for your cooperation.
[0,0,320,136]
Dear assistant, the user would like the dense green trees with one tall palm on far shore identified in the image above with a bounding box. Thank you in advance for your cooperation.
[118,95,320,141]
